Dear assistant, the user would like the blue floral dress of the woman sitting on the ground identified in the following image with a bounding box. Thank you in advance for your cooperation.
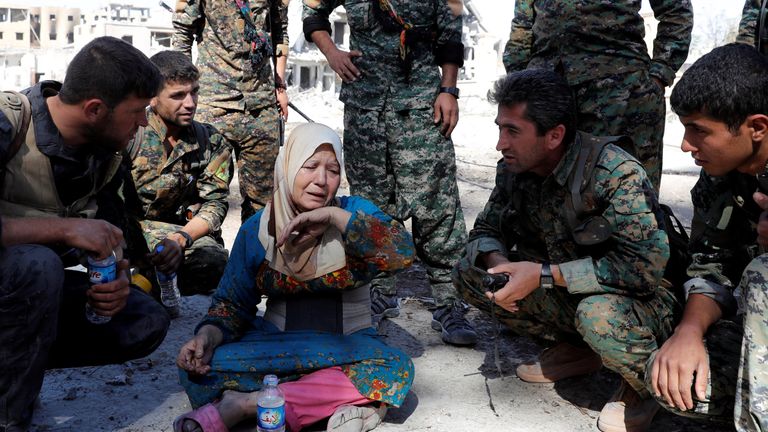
[179,197,414,408]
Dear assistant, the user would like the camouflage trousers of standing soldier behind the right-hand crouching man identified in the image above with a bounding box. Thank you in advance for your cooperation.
[574,71,666,193]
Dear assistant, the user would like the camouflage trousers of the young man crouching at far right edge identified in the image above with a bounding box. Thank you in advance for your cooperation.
[646,255,768,432]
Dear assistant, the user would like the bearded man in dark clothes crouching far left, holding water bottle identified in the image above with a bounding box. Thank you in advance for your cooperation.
[0,37,170,432]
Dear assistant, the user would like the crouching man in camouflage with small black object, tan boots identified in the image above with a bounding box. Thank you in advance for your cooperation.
[454,69,675,432]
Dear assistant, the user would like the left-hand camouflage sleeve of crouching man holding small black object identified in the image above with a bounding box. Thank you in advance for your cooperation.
[467,166,514,262]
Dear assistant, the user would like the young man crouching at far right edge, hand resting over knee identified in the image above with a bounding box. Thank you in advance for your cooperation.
[646,44,768,431]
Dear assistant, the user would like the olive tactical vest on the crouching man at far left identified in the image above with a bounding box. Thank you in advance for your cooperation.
[0,93,122,218]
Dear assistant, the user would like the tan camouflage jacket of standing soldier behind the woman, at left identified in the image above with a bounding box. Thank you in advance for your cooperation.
[173,0,288,111]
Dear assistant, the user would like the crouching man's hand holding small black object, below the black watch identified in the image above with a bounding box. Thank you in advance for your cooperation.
[485,261,541,312]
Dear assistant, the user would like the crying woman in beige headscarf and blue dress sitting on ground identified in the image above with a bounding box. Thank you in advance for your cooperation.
[174,123,414,432]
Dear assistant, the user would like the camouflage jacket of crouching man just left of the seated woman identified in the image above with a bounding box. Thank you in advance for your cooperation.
[126,111,232,233]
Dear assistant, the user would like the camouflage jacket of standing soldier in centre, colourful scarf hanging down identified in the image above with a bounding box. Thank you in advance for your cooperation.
[303,0,464,111]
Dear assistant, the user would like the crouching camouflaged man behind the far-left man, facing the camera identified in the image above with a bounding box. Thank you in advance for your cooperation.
[124,51,232,295]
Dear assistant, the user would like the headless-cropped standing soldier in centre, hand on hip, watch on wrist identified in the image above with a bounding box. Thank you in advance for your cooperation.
[303,0,477,345]
